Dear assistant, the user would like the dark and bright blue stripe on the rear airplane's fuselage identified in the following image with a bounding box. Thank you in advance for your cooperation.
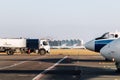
[95,39,114,52]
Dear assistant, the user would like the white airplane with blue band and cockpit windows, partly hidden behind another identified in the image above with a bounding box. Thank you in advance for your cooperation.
[85,31,120,52]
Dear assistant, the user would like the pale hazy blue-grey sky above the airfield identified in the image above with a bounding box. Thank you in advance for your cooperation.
[0,0,120,42]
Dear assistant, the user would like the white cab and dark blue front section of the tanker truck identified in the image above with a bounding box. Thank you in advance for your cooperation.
[27,39,50,55]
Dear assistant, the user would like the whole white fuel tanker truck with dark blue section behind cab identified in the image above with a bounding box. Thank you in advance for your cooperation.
[0,38,50,55]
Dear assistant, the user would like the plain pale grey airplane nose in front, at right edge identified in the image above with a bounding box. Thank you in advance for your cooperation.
[100,38,120,72]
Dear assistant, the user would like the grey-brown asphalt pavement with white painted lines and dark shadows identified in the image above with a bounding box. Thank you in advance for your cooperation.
[0,54,120,80]
